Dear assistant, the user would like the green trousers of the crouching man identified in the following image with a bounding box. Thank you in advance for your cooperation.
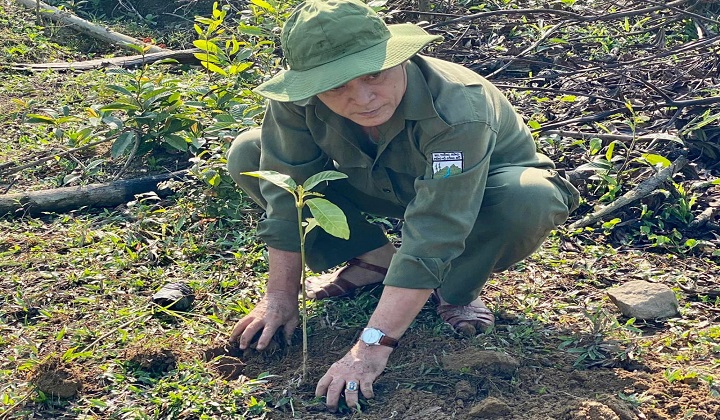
[227,129,579,305]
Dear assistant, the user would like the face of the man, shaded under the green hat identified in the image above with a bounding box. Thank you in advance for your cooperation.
[317,64,407,127]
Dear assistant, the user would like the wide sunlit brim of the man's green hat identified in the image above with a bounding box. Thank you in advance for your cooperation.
[253,24,442,102]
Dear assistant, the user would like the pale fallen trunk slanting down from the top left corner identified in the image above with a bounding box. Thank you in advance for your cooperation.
[15,0,165,53]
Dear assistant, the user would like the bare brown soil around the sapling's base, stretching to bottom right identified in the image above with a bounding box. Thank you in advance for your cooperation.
[208,302,720,420]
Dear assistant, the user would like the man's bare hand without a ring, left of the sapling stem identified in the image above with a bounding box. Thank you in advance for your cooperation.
[230,292,300,350]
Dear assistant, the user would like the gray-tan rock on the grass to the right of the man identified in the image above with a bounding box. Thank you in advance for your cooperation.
[607,280,678,319]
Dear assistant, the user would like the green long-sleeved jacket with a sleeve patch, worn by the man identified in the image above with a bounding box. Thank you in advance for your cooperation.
[258,55,553,289]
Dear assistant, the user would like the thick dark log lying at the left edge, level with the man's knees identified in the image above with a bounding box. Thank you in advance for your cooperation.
[0,171,187,216]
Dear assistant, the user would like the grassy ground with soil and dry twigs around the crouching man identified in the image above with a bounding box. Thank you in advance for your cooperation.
[0,1,720,420]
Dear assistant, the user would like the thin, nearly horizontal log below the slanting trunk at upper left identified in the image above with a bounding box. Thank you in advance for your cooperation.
[11,48,201,71]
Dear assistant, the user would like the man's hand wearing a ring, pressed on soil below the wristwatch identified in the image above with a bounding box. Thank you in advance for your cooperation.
[315,343,392,411]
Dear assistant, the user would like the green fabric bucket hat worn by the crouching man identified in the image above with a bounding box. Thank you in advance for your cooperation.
[254,0,442,102]
